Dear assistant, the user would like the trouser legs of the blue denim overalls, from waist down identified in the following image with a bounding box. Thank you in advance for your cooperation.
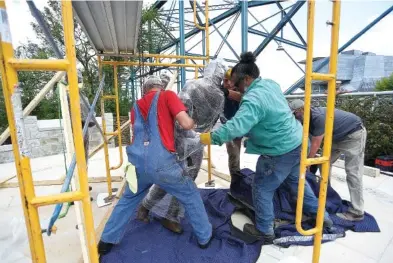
[101,163,212,245]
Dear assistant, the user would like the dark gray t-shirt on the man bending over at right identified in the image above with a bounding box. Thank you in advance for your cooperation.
[310,107,362,141]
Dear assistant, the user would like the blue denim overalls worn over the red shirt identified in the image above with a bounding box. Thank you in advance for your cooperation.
[101,92,212,245]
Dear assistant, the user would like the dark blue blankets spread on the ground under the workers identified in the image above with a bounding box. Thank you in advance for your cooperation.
[101,169,380,263]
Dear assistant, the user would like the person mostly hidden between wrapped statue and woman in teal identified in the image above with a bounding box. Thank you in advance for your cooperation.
[220,69,242,188]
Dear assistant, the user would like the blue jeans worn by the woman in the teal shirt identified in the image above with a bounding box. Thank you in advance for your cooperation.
[252,146,329,234]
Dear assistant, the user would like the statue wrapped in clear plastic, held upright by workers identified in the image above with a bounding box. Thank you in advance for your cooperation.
[138,60,226,232]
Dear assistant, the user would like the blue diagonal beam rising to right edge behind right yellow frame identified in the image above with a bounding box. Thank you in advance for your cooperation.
[284,5,393,95]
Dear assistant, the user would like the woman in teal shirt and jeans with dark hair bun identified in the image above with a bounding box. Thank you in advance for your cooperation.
[200,52,333,244]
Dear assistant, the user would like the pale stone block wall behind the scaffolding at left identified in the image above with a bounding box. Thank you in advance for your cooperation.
[0,113,114,163]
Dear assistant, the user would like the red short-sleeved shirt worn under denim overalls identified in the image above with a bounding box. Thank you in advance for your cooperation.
[131,90,187,152]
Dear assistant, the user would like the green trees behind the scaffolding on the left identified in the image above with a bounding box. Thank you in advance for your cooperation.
[0,1,168,138]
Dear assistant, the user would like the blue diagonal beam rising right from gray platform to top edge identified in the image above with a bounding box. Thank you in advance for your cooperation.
[159,1,277,53]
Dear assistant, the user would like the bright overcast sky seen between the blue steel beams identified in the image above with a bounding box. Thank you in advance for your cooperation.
[6,0,393,90]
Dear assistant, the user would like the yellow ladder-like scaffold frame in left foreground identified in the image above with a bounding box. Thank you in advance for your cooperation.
[0,0,98,263]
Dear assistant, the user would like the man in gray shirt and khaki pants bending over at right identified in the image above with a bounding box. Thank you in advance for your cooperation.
[289,100,367,221]
